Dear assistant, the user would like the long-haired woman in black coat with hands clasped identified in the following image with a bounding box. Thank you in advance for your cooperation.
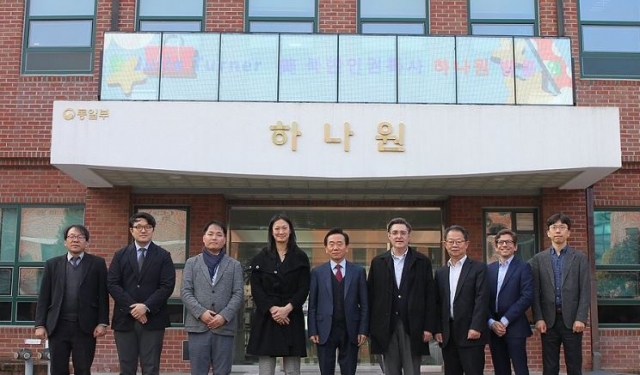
[247,214,311,375]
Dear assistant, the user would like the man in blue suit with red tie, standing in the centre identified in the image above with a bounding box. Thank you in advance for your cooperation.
[308,228,369,375]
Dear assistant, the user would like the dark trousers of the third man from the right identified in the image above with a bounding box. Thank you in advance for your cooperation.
[442,320,484,375]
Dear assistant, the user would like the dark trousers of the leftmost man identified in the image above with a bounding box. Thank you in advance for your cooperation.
[49,320,96,375]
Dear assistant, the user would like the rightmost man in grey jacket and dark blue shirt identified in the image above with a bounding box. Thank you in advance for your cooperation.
[531,214,591,375]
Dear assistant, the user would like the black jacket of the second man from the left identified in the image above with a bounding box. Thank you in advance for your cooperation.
[107,242,176,331]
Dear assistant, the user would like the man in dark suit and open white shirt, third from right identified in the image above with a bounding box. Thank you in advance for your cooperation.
[435,225,489,375]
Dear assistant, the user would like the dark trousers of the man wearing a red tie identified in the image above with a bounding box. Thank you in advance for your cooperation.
[318,326,360,375]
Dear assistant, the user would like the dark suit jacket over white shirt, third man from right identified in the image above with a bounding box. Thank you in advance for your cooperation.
[436,257,489,347]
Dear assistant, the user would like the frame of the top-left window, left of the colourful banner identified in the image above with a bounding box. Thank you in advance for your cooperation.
[20,0,98,75]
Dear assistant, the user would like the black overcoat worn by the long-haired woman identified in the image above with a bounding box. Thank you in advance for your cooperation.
[247,246,311,357]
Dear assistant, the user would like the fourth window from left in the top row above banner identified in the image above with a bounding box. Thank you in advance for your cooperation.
[358,0,429,35]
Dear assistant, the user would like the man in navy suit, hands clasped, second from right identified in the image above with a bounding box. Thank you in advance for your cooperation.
[487,229,533,375]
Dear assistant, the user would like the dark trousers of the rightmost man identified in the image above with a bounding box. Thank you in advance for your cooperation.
[542,314,582,375]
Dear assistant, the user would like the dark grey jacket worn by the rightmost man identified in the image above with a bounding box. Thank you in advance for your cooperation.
[530,247,591,329]
